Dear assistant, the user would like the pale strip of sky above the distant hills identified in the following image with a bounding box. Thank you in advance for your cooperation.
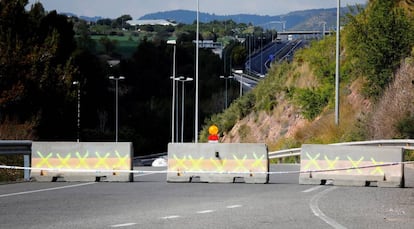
[29,0,367,19]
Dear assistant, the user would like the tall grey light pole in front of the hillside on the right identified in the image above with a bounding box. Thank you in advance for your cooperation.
[335,0,341,125]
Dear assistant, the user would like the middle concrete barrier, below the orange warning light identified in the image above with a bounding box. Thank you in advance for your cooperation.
[167,143,269,183]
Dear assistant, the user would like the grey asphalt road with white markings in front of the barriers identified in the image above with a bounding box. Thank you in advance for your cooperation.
[0,165,414,229]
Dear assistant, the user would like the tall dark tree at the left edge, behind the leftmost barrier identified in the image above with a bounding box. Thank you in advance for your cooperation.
[0,0,76,140]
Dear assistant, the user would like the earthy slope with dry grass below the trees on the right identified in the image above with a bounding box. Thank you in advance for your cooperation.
[202,39,414,150]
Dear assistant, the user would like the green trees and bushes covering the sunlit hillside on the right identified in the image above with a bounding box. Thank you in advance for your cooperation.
[201,1,414,148]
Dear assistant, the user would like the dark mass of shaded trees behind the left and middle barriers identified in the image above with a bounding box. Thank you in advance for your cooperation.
[0,0,274,158]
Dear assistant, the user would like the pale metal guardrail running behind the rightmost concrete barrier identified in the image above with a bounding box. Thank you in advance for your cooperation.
[269,139,414,159]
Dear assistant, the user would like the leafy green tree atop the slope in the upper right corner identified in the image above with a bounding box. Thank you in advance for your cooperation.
[347,0,414,99]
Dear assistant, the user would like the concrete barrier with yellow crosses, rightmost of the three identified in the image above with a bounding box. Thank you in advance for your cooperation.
[299,145,404,187]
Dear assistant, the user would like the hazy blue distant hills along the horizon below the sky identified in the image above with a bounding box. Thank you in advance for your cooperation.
[139,7,360,30]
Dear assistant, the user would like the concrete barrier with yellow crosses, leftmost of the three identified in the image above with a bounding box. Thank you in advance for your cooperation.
[31,142,133,182]
